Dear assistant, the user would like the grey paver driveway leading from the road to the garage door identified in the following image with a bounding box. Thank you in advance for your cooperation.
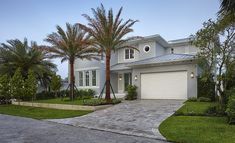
[50,100,183,140]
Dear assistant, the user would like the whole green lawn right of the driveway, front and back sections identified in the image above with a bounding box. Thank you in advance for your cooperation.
[159,102,235,143]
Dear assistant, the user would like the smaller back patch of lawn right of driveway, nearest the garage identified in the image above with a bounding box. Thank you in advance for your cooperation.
[175,101,217,115]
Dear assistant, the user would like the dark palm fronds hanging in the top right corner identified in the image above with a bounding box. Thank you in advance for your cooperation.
[219,0,235,15]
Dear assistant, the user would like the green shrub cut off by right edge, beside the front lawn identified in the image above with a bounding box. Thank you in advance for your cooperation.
[226,93,235,124]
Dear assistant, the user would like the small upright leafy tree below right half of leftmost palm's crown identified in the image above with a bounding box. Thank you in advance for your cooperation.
[24,70,37,100]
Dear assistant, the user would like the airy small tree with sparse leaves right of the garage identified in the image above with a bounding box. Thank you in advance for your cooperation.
[193,16,235,108]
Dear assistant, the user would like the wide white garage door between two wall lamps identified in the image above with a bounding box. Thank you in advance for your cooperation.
[141,71,187,99]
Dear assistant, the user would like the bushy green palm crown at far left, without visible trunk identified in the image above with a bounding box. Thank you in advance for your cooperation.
[0,39,57,84]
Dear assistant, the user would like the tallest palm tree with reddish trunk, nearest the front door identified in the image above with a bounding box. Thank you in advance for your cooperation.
[79,4,137,102]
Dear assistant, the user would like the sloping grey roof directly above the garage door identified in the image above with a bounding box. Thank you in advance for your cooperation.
[126,54,195,66]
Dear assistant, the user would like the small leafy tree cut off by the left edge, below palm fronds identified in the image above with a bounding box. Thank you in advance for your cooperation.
[0,74,11,99]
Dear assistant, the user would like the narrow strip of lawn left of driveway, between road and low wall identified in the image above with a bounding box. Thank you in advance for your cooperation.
[0,105,91,119]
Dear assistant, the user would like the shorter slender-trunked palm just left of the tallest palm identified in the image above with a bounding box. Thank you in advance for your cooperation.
[45,23,97,100]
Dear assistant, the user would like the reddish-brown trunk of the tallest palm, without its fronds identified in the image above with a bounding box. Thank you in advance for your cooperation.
[105,52,111,102]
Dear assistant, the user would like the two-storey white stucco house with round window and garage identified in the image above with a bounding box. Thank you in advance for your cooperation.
[72,35,199,99]
